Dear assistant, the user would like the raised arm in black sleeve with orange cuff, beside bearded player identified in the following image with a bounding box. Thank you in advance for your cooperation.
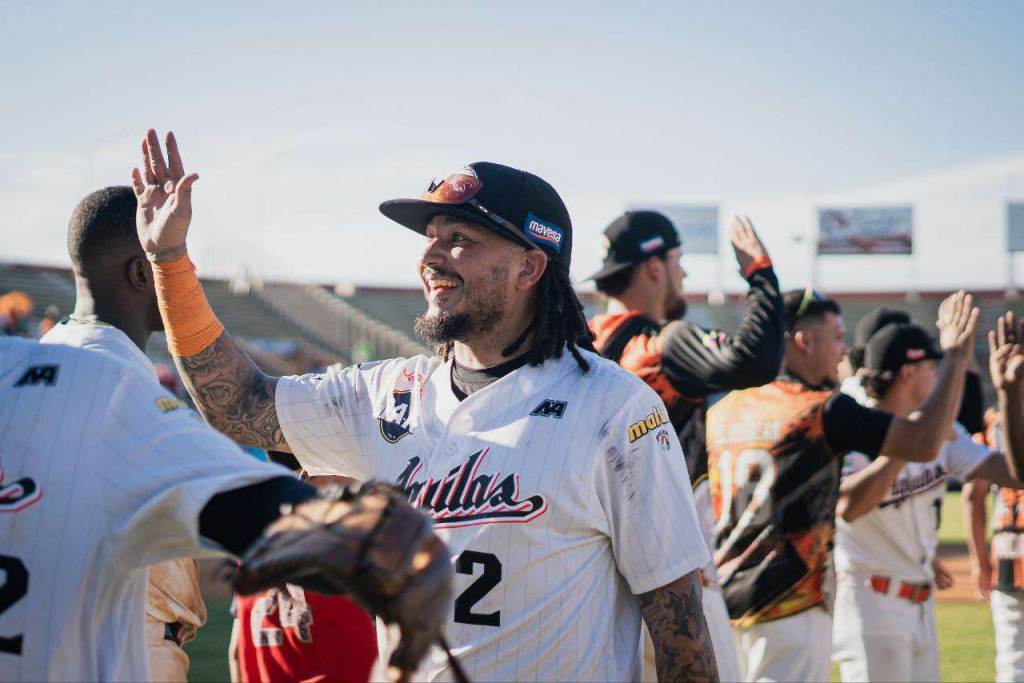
[662,216,785,398]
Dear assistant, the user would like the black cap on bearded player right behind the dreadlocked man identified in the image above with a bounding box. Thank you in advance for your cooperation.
[588,211,683,280]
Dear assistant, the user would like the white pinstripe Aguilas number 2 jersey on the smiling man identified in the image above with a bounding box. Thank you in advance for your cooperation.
[276,352,709,681]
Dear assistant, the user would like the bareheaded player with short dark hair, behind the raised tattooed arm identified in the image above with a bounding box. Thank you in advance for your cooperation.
[40,186,199,681]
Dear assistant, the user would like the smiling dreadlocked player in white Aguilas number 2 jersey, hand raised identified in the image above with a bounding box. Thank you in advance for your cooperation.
[133,131,717,681]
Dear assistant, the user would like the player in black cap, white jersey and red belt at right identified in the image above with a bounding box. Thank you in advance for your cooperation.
[833,319,1024,682]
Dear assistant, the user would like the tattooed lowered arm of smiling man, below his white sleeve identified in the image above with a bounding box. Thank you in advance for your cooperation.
[637,571,718,683]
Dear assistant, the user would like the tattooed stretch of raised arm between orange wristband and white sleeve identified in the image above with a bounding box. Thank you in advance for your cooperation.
[174,332,289,451]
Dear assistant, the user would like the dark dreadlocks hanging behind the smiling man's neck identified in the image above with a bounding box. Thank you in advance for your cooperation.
[438,263,594,373]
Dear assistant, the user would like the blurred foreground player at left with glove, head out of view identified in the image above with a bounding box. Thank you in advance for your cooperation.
[0,339,451,681]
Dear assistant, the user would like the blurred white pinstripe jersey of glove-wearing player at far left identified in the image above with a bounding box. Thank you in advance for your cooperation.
[0,338,286,681]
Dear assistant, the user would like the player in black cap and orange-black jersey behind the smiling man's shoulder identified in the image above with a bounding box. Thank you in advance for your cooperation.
[591,211,784,680]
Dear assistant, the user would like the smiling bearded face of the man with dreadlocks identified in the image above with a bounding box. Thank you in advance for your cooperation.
[416,216,537,345]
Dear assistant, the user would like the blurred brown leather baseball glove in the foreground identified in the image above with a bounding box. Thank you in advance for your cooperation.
[234,483,462,680]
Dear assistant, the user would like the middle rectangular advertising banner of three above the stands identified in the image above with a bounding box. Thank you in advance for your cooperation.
[818,206,913,254]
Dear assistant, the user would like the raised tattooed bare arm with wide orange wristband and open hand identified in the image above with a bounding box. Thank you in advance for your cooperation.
[131,129,289,451]
